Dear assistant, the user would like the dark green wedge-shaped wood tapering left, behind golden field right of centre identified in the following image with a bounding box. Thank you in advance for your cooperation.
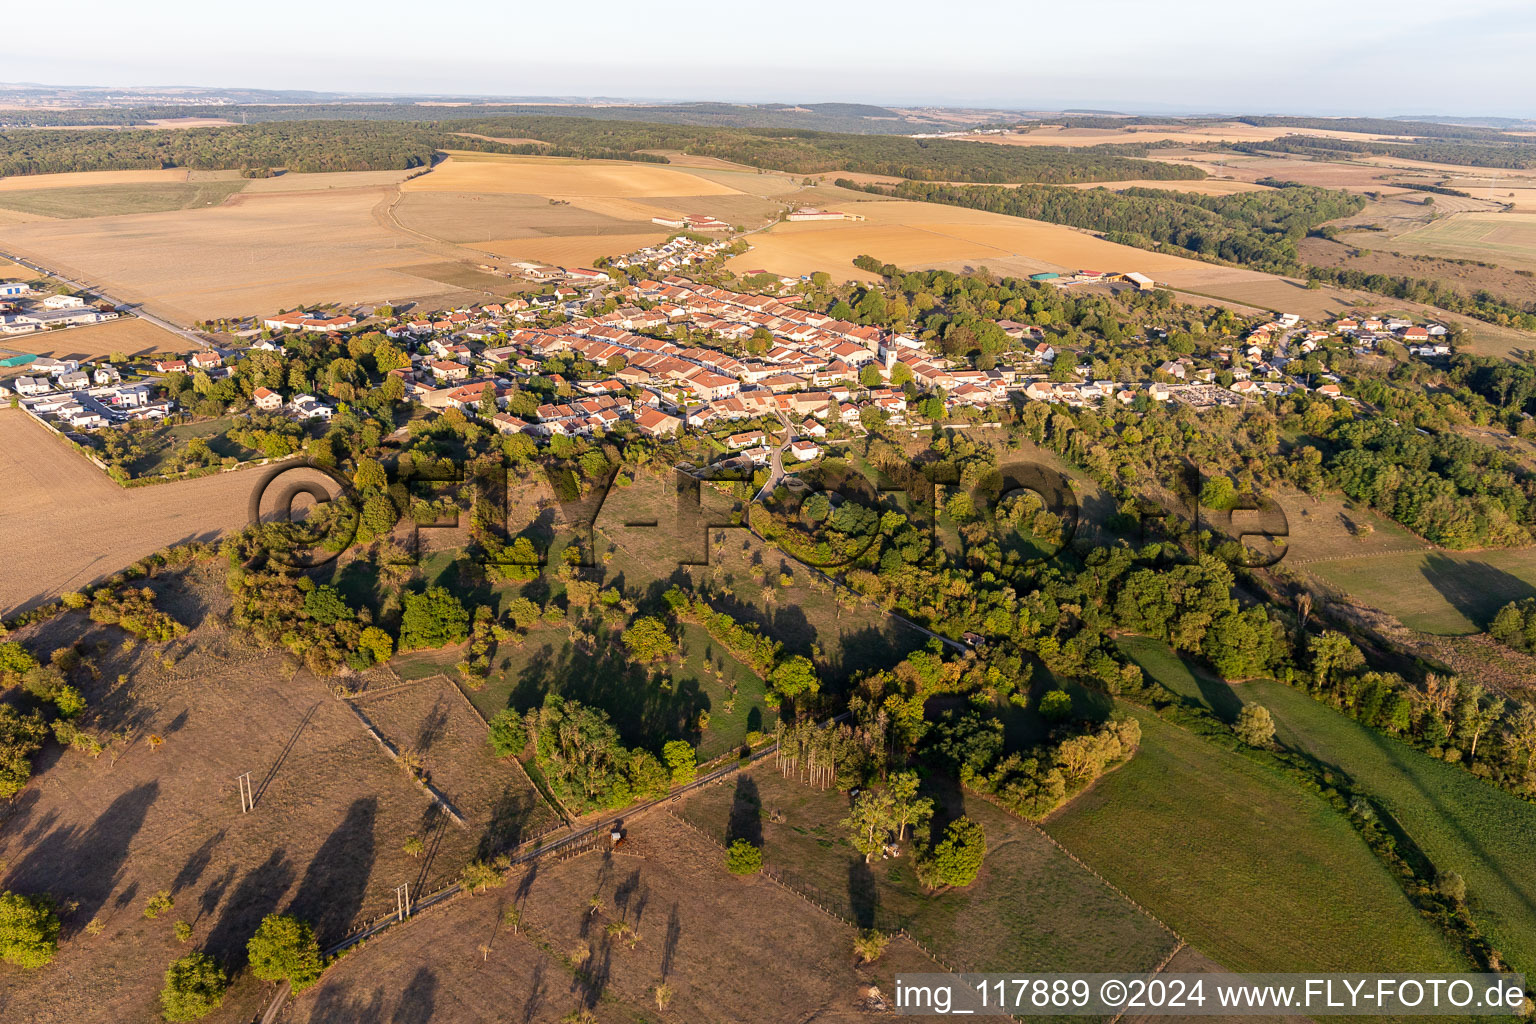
[837,178,1364,273]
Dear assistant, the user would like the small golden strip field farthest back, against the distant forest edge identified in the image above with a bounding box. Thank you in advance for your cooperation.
[401,154,736,200]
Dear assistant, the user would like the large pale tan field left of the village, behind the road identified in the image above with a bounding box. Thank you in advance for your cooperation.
[6,187,485,322]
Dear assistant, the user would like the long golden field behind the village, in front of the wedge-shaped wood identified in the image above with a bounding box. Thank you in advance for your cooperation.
[731,200,1267,287]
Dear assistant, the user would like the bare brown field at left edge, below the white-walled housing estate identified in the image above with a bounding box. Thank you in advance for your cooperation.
[0,408,347,616]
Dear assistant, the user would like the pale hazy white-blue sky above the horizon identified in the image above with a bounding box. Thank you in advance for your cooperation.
[12,0,1536,117]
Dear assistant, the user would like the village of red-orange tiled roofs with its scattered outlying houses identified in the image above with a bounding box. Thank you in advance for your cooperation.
[0,228,1450,465]
